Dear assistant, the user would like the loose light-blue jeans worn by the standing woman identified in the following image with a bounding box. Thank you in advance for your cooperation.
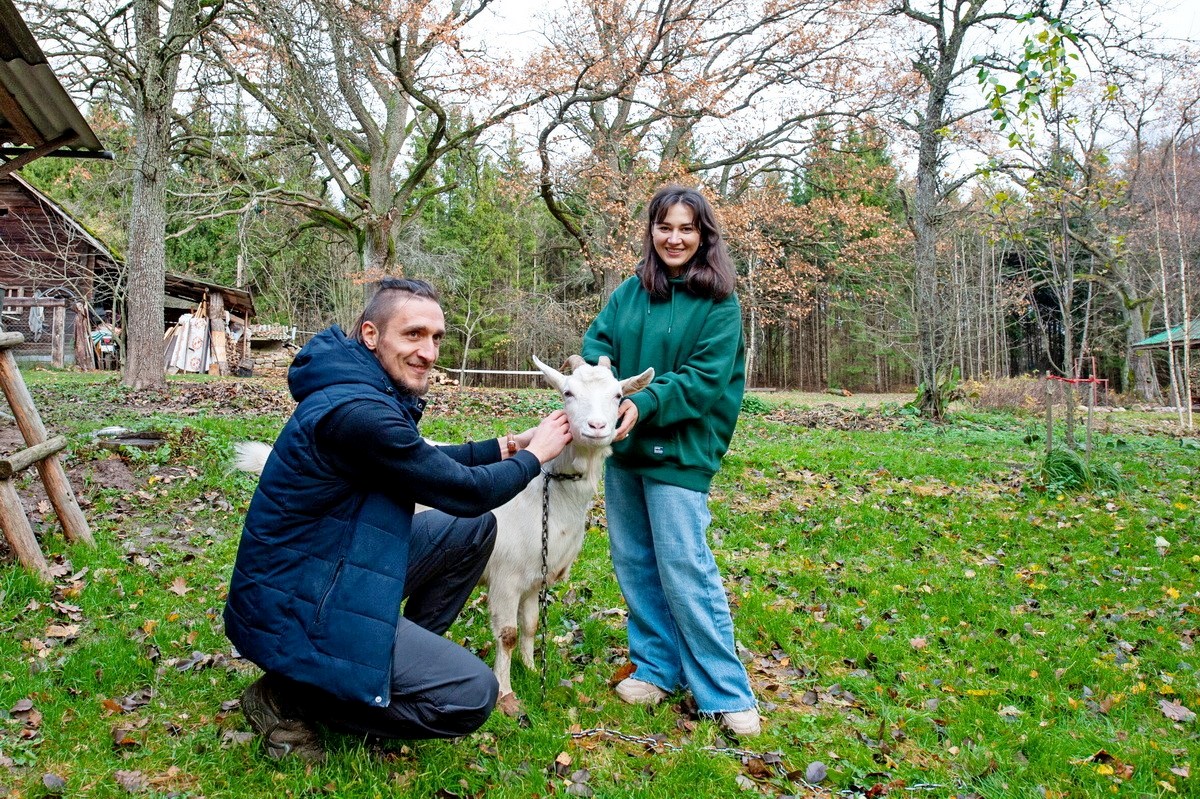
[605,461,756,714]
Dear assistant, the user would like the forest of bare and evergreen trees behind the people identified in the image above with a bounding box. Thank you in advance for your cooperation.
[9,0,1200,416]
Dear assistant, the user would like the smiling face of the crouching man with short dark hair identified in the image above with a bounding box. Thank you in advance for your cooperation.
[362,296,446,397]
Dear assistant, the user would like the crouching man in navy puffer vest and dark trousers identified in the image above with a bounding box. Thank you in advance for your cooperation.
[224,278,571,759]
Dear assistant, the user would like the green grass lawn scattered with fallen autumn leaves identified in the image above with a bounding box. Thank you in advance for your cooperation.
[0,372,1200,798]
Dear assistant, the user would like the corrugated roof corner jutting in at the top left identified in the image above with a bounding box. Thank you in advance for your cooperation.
[0,0,109,176]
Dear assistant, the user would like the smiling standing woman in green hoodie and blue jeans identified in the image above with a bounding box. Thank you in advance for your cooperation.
[583,186,760,735]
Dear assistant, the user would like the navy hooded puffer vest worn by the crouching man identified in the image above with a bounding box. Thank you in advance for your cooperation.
[224,328,425,707]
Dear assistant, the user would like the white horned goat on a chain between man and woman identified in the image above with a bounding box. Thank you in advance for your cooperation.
[234,355,654,715]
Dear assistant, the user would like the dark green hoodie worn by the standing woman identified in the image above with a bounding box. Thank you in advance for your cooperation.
[582,277,745,492]
